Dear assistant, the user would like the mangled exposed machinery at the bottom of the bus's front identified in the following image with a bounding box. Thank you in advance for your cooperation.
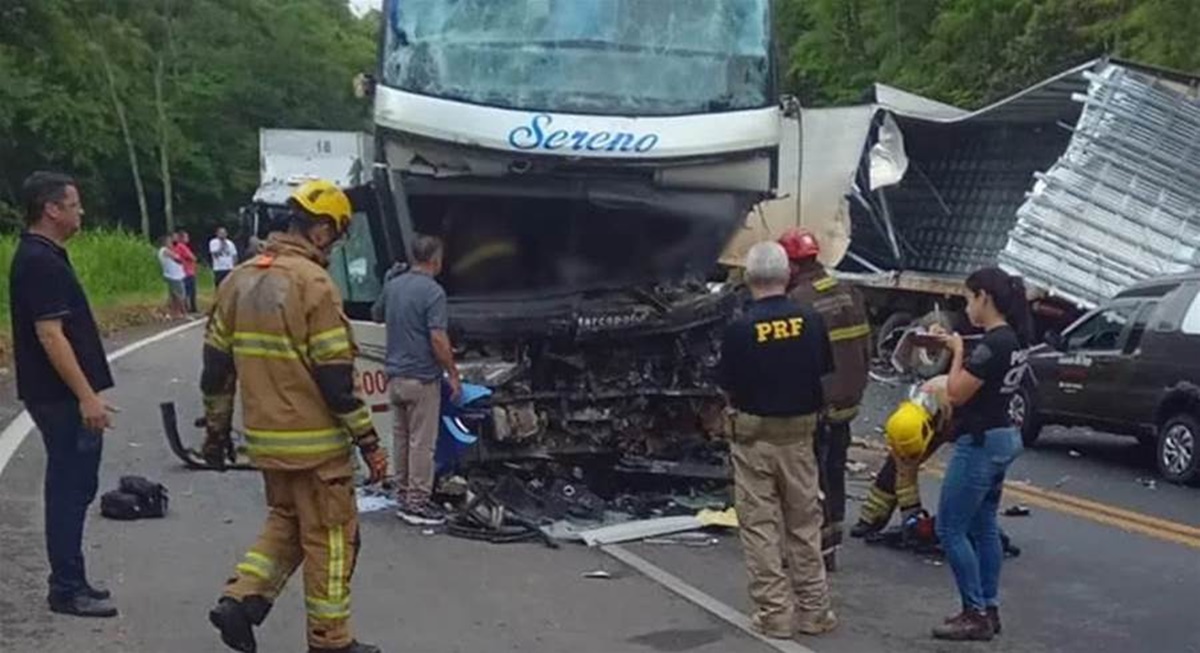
[446,283,737,473]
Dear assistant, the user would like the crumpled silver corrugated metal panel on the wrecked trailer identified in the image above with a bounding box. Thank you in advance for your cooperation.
[1000,64,1200,306]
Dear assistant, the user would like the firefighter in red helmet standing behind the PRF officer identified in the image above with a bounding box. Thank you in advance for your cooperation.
[779,229,871,550]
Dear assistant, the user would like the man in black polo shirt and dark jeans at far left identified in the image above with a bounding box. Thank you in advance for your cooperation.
[8,173,116,617]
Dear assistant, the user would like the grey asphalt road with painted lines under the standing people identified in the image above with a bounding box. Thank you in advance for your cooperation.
[0,330,1200,653]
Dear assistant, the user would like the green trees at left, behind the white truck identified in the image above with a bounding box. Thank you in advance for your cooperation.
[0,0,378,233]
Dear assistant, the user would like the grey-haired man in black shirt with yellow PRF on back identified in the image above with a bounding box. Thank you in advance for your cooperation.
[719,242,838,639]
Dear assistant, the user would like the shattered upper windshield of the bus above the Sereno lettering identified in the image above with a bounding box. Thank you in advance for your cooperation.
[383,0,770,115]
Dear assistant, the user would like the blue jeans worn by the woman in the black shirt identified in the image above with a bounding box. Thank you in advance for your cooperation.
[937,429,1024,610]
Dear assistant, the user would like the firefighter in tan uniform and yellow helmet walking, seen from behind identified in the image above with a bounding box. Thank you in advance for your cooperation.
[200,181,388,653]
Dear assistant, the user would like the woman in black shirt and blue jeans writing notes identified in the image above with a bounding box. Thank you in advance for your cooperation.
[934,268,1030,640]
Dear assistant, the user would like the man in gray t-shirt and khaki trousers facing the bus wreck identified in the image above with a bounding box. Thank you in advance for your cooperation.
[376,235,462,526]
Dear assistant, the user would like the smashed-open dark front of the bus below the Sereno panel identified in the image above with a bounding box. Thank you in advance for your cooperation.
[396,180,752,466]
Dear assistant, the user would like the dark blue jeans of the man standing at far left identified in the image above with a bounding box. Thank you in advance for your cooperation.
[25,401,103,601]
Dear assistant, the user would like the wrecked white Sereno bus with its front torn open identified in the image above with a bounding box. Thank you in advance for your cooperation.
[348,0,781,469]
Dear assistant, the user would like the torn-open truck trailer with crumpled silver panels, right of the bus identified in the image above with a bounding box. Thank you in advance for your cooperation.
[725,59,1200,376]
